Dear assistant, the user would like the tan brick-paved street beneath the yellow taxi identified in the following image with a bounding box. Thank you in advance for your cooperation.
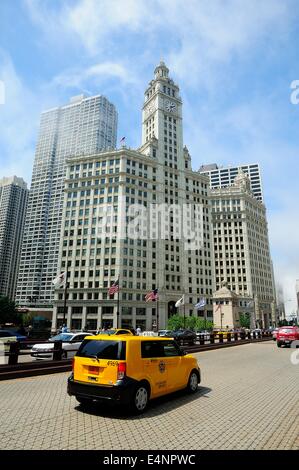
[0,341,299,450]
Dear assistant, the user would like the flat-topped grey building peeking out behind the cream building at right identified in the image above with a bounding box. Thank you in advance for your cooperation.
[198,163,263,202]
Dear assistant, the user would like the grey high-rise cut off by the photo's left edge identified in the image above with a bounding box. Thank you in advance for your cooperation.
[0,176,28,300]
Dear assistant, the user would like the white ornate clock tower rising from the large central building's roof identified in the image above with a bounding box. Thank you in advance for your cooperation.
[141,61,185,170]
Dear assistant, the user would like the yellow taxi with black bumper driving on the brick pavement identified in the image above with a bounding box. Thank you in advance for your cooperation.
[68,335,201,412]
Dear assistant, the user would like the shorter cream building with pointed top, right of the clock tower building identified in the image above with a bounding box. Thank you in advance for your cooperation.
[211,170,277,327]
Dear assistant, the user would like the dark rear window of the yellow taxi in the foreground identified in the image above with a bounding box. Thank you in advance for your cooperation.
[76,339,126,360]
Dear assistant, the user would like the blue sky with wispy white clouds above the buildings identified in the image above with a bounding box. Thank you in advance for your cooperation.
[0,0,299,312]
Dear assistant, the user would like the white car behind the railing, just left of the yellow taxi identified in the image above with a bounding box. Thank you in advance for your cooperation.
[31,332,90,360]
